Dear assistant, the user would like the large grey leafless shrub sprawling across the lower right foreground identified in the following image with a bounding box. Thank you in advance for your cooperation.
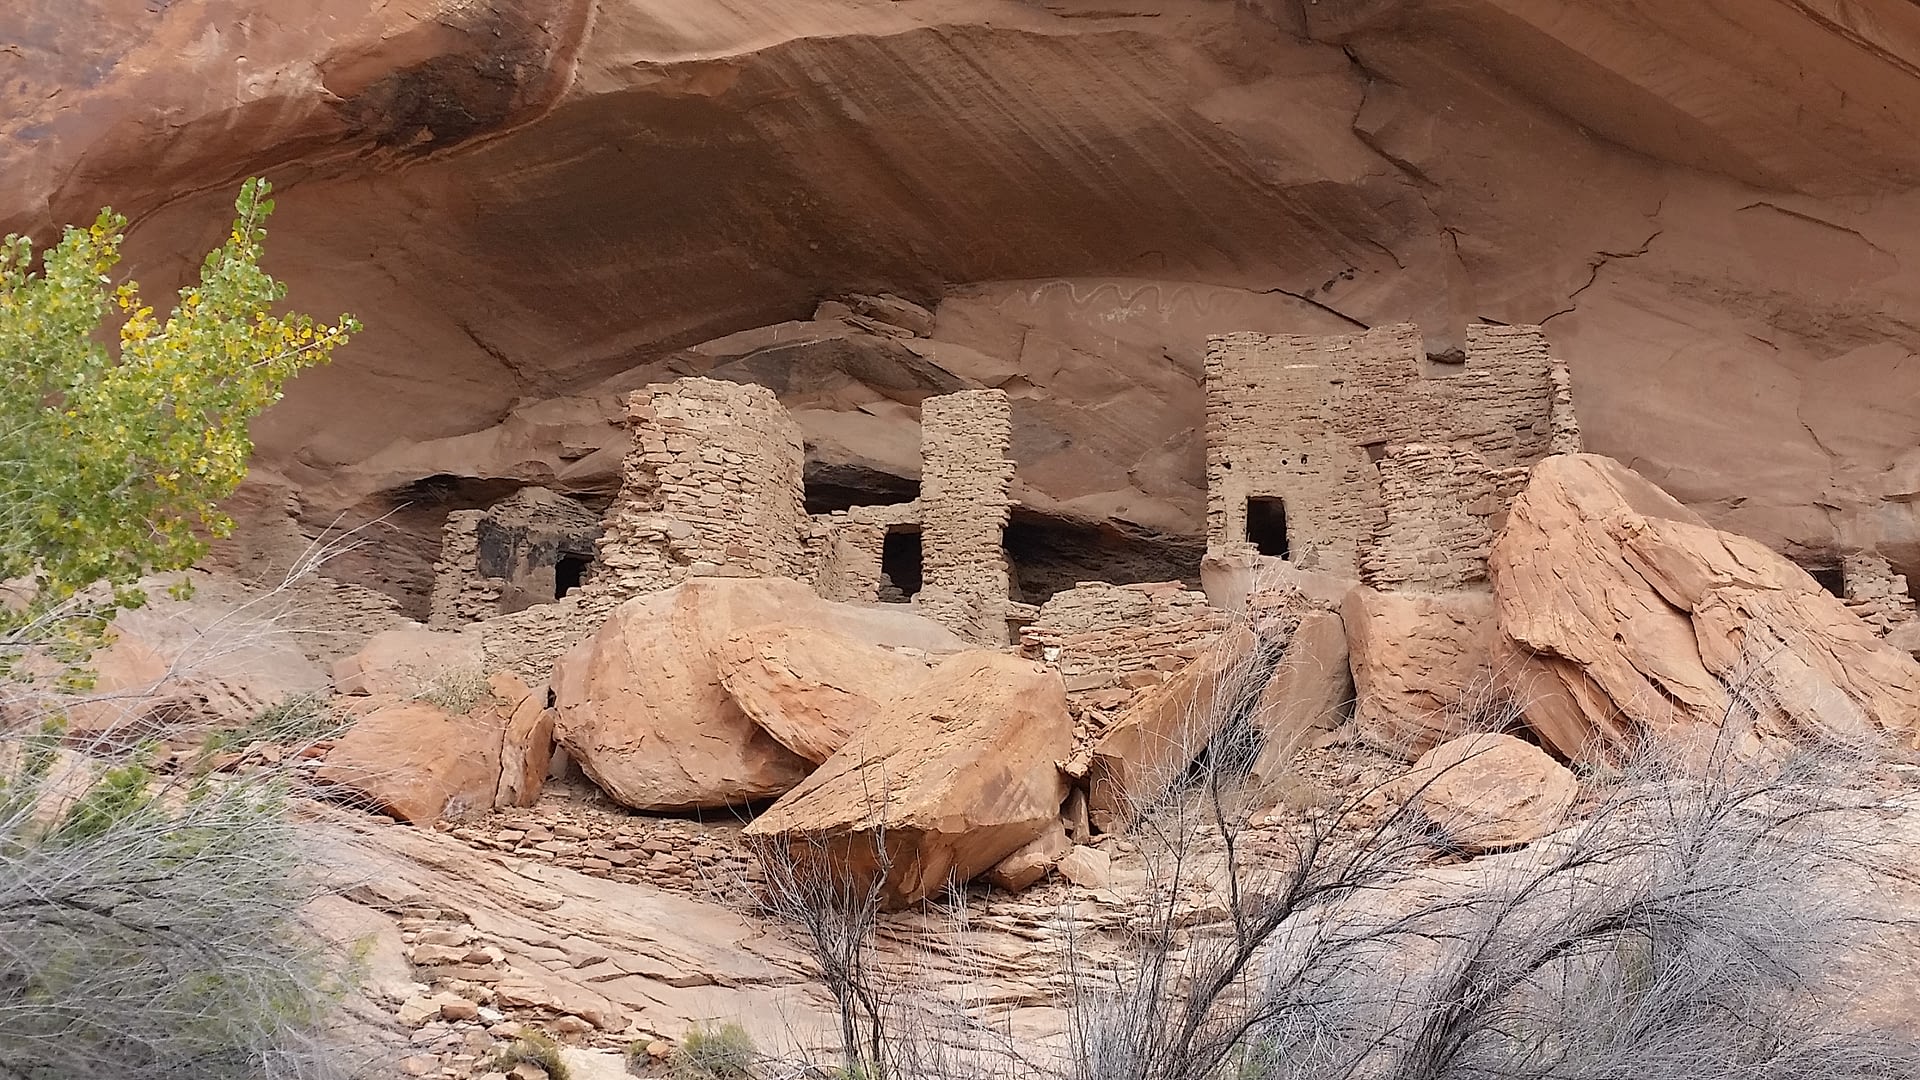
[1069,661,1920,1080]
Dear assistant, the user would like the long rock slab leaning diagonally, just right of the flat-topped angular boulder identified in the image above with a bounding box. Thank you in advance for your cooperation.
[1087,625,1260,832]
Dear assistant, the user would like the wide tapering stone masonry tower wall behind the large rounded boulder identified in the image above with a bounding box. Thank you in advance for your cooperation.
[591,379,812,600]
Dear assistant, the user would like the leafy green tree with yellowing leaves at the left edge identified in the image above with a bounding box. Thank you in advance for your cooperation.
[0,179,359,667]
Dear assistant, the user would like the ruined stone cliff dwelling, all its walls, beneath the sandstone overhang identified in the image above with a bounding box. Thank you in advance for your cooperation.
[420,315,1914,691]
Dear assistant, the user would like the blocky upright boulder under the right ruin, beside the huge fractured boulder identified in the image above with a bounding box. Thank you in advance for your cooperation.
[1340,588,1494,759]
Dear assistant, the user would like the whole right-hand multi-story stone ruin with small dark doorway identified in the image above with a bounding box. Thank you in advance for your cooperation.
[1206,325,1578,588]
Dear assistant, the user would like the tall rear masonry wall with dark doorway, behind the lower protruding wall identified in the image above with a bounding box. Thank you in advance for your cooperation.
[1206,317,1578,577]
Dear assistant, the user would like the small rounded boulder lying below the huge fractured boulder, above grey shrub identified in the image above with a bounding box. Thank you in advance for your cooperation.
[1380,732,1580,851]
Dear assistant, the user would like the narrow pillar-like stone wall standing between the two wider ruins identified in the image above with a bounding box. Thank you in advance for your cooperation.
[916,390,1014,646]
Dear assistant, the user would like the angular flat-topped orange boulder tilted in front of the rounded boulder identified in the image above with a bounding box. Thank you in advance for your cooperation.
[747,651,1073,907]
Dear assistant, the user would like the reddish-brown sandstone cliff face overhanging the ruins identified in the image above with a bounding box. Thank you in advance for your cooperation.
[11,0,1920,588]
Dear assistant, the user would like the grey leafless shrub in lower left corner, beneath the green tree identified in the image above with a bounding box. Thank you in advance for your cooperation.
[0,526,378,1080]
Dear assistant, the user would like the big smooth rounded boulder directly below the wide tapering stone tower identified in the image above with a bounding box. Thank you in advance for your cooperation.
[553,577,962,811]
